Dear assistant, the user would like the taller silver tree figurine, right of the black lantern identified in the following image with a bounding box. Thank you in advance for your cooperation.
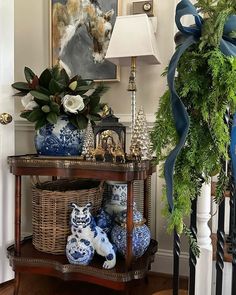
[130,107,152,160]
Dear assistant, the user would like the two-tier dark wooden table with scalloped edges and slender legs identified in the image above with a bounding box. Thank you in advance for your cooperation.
[8,155,157,295]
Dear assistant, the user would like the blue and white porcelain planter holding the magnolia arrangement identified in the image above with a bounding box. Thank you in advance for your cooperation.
[35,115,84,156]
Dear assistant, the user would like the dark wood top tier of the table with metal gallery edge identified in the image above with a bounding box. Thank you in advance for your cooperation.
[8,154,156,181]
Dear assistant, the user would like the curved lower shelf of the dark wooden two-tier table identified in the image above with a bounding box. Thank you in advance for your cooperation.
[8,239,157,290]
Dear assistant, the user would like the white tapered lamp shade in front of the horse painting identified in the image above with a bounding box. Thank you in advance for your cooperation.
[105,14,160,66]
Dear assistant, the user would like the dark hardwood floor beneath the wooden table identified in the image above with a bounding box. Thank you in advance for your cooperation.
[0,272,188,295]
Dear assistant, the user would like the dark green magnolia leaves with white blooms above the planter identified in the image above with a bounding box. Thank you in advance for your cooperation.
[12,65,107,130]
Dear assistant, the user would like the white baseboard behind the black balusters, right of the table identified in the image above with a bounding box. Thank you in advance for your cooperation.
[151,249,189,277]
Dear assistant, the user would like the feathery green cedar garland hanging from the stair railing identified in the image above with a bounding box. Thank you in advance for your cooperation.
[152,0,236,254]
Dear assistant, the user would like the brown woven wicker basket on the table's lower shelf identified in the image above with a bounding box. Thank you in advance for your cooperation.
[32,179,103,254]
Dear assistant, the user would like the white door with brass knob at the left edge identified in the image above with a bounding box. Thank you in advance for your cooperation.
[0,0,15,283]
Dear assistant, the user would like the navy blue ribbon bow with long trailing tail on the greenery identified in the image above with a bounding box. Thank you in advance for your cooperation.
[164,0,236,212]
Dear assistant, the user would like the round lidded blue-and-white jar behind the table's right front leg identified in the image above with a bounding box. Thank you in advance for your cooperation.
[111,209,151,258]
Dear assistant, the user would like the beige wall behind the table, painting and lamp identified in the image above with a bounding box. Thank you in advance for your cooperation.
[15,0,186,272]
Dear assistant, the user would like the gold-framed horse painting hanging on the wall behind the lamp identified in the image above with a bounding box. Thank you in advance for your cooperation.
[49,0,121,81]
